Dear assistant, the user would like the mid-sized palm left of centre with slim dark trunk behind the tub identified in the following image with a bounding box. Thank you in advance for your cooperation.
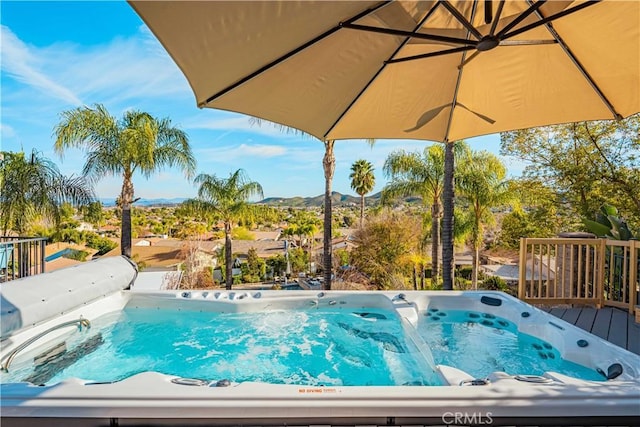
[185,169,263,290]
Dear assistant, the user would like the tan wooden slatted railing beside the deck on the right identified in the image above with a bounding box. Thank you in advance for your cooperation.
[518,238,640,313]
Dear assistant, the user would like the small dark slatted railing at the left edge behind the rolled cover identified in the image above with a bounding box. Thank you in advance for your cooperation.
[0,236,47,282]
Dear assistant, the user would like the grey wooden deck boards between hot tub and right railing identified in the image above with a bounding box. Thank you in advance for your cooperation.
[539,307,640,355]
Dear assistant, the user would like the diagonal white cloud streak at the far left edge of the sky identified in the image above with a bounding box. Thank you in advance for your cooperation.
[1,25,82,105]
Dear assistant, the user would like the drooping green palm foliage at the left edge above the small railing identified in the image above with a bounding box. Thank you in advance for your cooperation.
[0,150,95,236]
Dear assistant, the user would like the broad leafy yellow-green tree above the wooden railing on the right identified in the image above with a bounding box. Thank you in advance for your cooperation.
[501,114,640,231]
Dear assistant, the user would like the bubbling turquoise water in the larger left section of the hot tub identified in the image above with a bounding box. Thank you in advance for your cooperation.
[4,308,442,386]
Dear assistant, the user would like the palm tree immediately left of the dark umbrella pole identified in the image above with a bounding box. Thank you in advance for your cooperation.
[383,141,468,288]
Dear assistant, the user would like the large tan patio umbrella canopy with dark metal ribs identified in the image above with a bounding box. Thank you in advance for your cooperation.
[130,0,640,286]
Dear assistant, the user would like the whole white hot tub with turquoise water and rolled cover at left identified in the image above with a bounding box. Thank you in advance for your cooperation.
[1,258,640,425]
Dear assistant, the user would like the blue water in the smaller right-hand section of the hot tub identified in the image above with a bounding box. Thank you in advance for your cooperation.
[418,308,606,381]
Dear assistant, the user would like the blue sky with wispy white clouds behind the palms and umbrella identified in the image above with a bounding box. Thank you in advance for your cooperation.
[0,0,523,198]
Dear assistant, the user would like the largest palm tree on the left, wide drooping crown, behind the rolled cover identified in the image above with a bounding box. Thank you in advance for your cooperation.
[54,104,196,257]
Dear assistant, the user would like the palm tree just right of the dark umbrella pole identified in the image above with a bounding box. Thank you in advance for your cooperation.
[456,151,511,289]
